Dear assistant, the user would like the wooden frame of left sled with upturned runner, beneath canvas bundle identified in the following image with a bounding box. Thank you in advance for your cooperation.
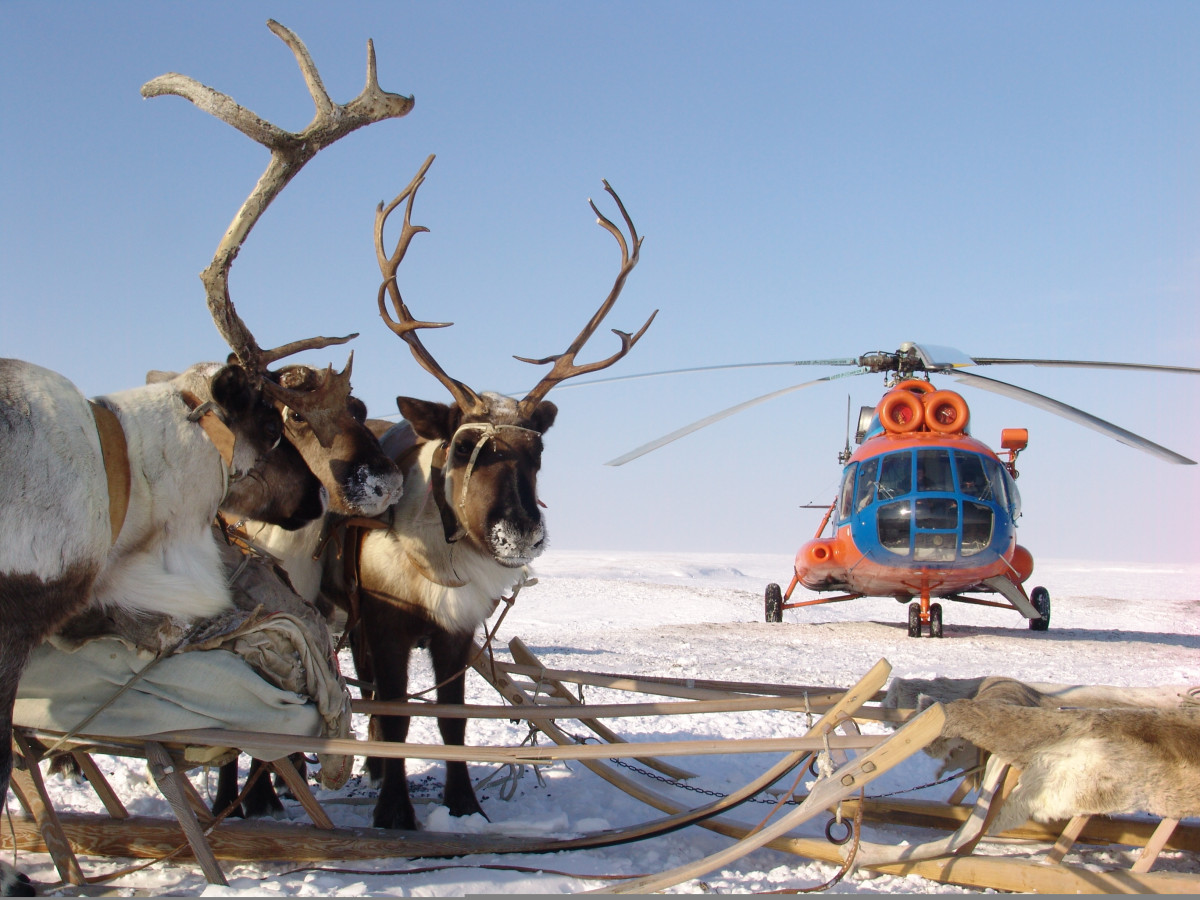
[0,641,902,884]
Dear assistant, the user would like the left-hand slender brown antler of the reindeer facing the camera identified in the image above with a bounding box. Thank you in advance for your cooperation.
[374,155,485,413]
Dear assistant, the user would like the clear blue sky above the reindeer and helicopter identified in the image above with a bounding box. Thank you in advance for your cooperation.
[0,0,1200,564]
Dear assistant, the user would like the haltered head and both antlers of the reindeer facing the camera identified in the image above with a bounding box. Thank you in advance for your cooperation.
[376,156,658,568]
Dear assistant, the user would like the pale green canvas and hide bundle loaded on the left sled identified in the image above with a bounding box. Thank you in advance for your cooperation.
[17,535,353,788]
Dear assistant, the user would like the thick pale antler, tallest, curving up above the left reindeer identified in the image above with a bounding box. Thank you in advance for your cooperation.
[142,19,414,417]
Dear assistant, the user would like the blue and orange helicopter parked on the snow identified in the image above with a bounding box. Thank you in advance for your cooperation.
[604,343,1200,637]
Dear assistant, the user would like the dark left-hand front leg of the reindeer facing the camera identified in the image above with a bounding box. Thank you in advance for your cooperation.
[361,601,421,832]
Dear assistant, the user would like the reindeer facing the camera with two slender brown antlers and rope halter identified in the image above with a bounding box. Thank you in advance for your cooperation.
[215,156,658,829]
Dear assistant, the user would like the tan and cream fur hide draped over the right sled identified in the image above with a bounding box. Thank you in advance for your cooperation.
[884,678,1200,833]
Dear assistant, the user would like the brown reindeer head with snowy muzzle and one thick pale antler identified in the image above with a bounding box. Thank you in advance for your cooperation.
[142,20,413,516]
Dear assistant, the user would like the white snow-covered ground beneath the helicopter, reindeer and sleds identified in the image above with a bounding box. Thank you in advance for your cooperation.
[11,551,1200,896]
